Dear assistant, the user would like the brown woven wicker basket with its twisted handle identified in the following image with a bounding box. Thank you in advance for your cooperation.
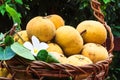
[0,0,114,80]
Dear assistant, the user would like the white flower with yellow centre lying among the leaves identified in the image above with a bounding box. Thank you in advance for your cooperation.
[23,36,49,56]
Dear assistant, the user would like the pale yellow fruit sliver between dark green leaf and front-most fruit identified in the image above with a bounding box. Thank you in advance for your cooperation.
[50,52,67,64]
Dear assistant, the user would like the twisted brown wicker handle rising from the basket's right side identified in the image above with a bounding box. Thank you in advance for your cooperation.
[90,0,114,53]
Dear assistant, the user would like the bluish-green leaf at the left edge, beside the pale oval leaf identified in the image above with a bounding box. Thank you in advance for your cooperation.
[0,46,15,60]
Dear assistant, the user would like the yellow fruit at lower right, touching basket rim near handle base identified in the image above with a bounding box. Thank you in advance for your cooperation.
[81,43,108,63]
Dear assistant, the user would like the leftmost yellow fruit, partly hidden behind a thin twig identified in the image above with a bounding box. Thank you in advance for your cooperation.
[13,30,29,44]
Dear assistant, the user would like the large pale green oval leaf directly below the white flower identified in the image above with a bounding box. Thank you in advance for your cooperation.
[11,42,35,60]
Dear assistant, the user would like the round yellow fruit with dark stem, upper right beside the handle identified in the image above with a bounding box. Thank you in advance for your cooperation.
[76,20,107,44]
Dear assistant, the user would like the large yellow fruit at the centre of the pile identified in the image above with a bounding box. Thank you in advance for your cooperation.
[55,25,83,56]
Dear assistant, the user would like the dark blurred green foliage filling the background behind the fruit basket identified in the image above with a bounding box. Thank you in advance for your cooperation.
[0,0,120,80]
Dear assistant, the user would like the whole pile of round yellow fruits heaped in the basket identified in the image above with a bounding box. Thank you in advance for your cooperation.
[14,14,108,66]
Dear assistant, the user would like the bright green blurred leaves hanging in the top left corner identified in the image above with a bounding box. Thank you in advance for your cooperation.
[0,0,23,29]
